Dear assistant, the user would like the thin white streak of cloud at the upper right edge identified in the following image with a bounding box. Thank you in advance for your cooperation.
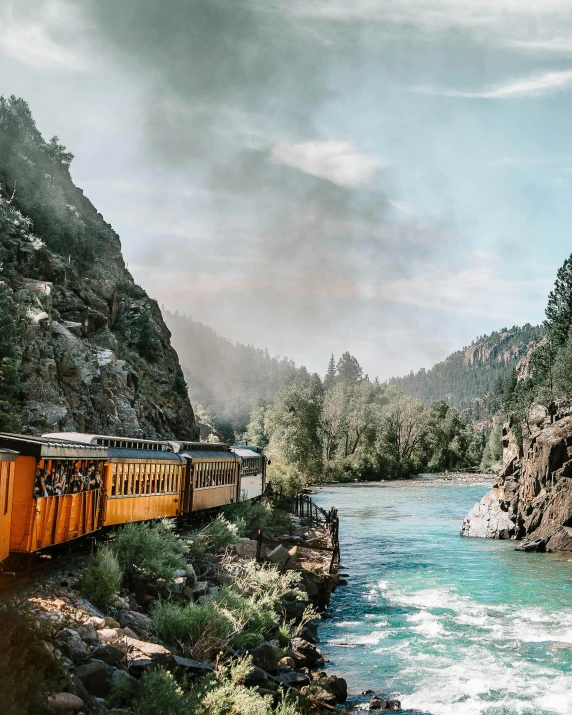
[414,70,572,99]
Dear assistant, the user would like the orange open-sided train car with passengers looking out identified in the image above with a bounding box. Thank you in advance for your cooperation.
[0,433,107,553]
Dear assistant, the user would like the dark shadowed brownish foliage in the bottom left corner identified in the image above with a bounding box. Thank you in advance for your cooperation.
[0,608,65,715]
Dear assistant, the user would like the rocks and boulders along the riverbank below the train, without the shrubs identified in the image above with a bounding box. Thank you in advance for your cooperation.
[0,506,400,715]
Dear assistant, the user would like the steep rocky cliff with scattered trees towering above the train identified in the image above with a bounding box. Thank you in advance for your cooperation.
[0,98,197,439]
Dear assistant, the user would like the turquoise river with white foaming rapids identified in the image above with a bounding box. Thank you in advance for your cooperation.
[315,477,572,715]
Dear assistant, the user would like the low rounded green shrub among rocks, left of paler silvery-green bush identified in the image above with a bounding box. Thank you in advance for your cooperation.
[151,601,236,660]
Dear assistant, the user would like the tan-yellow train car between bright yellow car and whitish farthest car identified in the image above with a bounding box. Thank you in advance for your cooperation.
[169,442,240,514]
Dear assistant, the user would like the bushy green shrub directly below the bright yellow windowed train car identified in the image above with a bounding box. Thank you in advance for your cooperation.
[113,519,187,592]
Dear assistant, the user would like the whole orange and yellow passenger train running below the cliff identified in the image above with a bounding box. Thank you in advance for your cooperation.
[0,432,268,565]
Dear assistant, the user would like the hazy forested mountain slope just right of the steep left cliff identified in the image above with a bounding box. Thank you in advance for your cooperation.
[163,309,306,440]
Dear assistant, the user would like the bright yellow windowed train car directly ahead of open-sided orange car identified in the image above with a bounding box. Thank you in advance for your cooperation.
[44,433,186,526]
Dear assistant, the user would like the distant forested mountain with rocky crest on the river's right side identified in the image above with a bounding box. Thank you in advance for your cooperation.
[390,323,544,423]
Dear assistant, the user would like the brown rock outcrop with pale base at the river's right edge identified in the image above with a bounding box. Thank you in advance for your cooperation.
[461,412,572,551]
